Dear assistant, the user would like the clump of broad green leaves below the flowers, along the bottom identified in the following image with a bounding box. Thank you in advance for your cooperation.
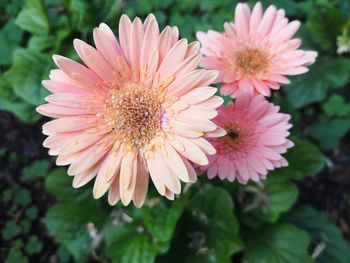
[40,136,323,262]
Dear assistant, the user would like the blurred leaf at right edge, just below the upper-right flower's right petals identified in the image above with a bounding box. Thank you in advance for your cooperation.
[284,57,350,108]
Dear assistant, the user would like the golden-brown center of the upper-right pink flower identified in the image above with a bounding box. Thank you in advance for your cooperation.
[234,48,268,75]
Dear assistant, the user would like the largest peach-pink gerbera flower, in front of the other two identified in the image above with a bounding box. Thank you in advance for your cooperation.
[37,15,223,207]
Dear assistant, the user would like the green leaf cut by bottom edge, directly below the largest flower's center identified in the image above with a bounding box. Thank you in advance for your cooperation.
[104,224,157,263]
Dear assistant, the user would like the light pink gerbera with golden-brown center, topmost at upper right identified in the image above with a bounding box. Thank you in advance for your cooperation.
[197,3,317,97]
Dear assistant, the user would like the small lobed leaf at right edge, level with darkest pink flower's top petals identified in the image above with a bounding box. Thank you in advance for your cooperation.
[322,94,350,117]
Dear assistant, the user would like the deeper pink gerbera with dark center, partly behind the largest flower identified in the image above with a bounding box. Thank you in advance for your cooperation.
[200,92,293,184]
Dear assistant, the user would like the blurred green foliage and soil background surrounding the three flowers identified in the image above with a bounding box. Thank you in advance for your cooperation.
[0,0,350,263]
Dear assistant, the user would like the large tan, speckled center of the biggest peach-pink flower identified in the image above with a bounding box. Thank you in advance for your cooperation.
[105,84,162,151]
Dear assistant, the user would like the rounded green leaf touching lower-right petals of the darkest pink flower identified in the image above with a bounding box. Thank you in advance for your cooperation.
[268,140,324,183]
